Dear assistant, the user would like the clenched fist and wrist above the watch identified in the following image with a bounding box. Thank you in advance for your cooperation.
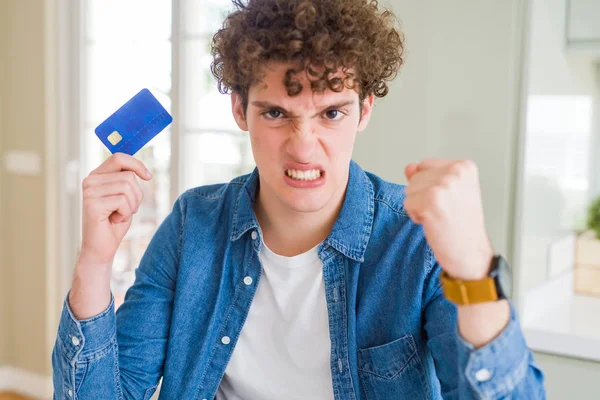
[404,159,494,280]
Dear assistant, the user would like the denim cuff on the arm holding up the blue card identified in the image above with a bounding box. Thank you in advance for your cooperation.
[58,294,116,362]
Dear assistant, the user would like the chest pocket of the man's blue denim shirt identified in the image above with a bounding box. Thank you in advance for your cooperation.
[358,335,430,400]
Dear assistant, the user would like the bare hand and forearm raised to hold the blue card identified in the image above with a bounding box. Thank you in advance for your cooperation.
[69,153,152,320]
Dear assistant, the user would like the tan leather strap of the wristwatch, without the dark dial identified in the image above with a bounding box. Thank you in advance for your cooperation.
[440,271,498,306]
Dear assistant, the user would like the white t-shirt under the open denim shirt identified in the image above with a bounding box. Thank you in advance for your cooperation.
[217,243,333,400]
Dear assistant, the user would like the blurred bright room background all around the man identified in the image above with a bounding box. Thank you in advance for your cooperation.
[0,0,600,400]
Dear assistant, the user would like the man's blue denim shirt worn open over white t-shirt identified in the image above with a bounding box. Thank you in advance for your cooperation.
[52,162,545,400]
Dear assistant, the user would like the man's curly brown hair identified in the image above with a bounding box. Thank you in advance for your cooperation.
[211,0,404,111]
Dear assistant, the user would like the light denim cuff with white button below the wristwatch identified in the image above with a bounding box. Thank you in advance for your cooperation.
[457,303,530,399]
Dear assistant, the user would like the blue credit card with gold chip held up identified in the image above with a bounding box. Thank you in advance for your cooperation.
[96,89,173,156]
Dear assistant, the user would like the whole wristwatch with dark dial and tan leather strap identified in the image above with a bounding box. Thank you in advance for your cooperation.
[440,254,512,306]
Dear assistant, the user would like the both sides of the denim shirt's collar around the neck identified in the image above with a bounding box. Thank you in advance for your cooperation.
[230,161,375,262]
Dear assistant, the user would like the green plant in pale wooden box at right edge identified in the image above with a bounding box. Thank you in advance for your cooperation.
[575,196,600,296]
